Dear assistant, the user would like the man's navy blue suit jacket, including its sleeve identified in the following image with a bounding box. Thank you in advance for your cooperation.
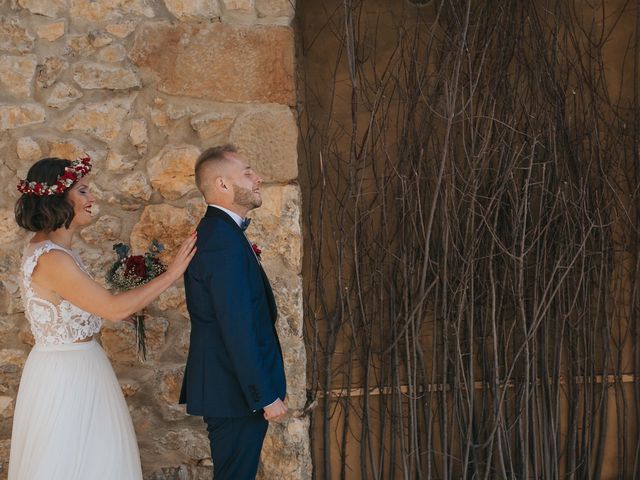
[180,206,286,417]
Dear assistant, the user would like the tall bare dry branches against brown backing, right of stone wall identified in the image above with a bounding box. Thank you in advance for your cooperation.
[298,0,640,479]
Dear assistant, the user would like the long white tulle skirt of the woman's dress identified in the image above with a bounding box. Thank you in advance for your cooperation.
[9,340,142,480]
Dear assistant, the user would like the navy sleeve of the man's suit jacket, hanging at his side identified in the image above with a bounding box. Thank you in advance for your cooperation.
[203,242,278,410]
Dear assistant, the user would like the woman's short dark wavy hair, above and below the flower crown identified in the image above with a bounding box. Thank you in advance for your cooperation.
[14,157,74,232]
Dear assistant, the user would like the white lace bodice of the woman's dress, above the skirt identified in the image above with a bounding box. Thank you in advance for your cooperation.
[21,240,102,345]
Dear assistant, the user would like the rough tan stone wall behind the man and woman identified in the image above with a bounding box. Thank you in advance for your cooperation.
[0,0,311,480]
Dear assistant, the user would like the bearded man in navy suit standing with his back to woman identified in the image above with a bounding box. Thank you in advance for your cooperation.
[180,145,287,480]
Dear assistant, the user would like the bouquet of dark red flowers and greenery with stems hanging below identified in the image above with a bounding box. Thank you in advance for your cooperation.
[107,239,167,361]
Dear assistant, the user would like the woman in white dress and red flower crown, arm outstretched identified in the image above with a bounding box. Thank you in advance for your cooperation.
[9,158,196,480]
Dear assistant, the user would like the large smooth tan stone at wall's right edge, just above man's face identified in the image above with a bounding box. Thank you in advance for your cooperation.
[230,106,298,182]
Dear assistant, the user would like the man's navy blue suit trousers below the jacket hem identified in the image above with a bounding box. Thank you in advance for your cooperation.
[204,410,269,480]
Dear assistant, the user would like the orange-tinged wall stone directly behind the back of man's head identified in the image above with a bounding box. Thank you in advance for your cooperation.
[147,145,200,200]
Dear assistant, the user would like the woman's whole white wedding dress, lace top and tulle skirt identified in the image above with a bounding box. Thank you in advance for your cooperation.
[9,241,142,480]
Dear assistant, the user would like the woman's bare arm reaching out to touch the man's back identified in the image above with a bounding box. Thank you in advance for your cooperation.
[32,234,196,322]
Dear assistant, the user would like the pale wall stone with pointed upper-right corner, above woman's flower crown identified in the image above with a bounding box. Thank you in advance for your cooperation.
[62,97,133,142]
